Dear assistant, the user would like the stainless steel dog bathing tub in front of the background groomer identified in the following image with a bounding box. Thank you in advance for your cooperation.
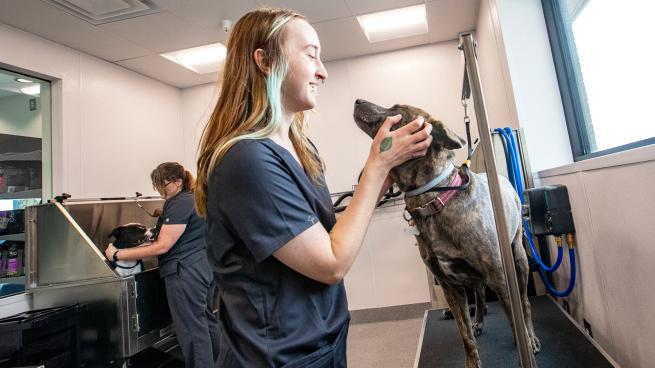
[26,199,172,362]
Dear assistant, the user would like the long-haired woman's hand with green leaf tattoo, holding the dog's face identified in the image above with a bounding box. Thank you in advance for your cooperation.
[369,115,432,172]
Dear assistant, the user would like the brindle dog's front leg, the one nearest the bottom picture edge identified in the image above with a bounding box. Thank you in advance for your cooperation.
[441,283,482,368]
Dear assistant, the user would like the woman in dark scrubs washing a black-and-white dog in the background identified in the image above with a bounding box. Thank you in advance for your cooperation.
[105,162,218,368]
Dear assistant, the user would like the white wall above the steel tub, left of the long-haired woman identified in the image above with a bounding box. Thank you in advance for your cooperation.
[0,24,185,198]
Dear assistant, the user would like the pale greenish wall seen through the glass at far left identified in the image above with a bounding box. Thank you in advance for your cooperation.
[0,94,43,138]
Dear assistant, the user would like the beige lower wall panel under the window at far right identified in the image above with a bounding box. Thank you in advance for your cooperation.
[541,161,655,368]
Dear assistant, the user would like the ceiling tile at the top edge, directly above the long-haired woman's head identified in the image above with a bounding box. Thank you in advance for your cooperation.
[258,0,351,23]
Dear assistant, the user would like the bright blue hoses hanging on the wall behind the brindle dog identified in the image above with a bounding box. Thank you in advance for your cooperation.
[495,128,576,297]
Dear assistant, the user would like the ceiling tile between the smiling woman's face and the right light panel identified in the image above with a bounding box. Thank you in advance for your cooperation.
[313,17,370,61]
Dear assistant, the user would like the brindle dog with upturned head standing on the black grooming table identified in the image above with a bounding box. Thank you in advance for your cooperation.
[353,100,540,368]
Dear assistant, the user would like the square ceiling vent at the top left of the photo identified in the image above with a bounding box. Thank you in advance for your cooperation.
[42,0,164,25]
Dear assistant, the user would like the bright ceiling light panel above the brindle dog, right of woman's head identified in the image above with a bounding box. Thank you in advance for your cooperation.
[357,4,428,43]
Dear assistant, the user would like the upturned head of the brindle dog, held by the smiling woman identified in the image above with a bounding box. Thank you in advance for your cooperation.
[353,99,466,191]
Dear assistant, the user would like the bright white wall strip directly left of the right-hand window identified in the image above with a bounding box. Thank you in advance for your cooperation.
[496,0,573,171]
